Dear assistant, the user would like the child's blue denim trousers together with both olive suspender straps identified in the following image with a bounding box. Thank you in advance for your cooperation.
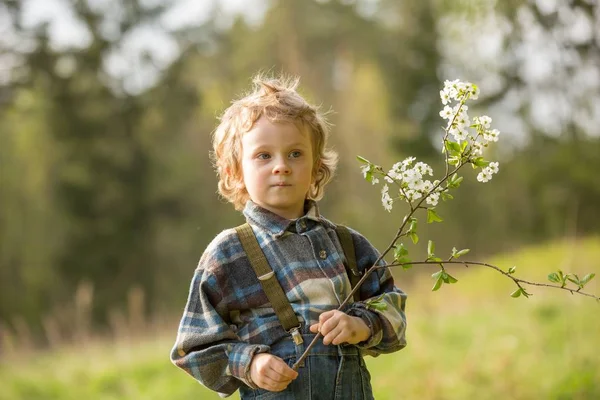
[236,224,373,400]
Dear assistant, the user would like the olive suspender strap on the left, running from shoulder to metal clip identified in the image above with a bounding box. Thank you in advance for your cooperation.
[235,223,302,345]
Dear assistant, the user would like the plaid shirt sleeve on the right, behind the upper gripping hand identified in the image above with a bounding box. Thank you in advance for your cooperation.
[346,230,406,356]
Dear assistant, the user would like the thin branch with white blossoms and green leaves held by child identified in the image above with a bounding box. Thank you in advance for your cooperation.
[293,80,600,370]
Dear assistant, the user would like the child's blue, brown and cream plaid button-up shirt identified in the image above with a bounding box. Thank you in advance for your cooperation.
[171,201,406,397]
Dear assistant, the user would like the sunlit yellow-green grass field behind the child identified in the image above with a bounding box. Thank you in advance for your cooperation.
[0,238,600,400]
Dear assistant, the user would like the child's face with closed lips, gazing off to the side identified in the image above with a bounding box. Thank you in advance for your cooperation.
[242,117,313,219]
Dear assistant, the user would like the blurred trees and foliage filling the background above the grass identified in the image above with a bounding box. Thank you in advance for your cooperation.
[0,0,600,388]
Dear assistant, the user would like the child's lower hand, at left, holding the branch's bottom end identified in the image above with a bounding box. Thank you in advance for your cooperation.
[250,353,298,392]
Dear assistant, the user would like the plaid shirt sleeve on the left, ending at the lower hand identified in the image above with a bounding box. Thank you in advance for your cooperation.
[171,254,270,397]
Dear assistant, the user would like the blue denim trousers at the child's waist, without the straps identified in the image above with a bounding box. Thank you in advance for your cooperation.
[240,334,373,400]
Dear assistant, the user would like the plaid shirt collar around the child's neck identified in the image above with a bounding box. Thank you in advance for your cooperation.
[243,200,335,238]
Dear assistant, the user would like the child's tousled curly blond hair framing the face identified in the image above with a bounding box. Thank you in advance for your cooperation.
[211,75,338,210]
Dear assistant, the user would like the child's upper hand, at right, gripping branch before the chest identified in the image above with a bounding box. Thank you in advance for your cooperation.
[310,310,371,345]
